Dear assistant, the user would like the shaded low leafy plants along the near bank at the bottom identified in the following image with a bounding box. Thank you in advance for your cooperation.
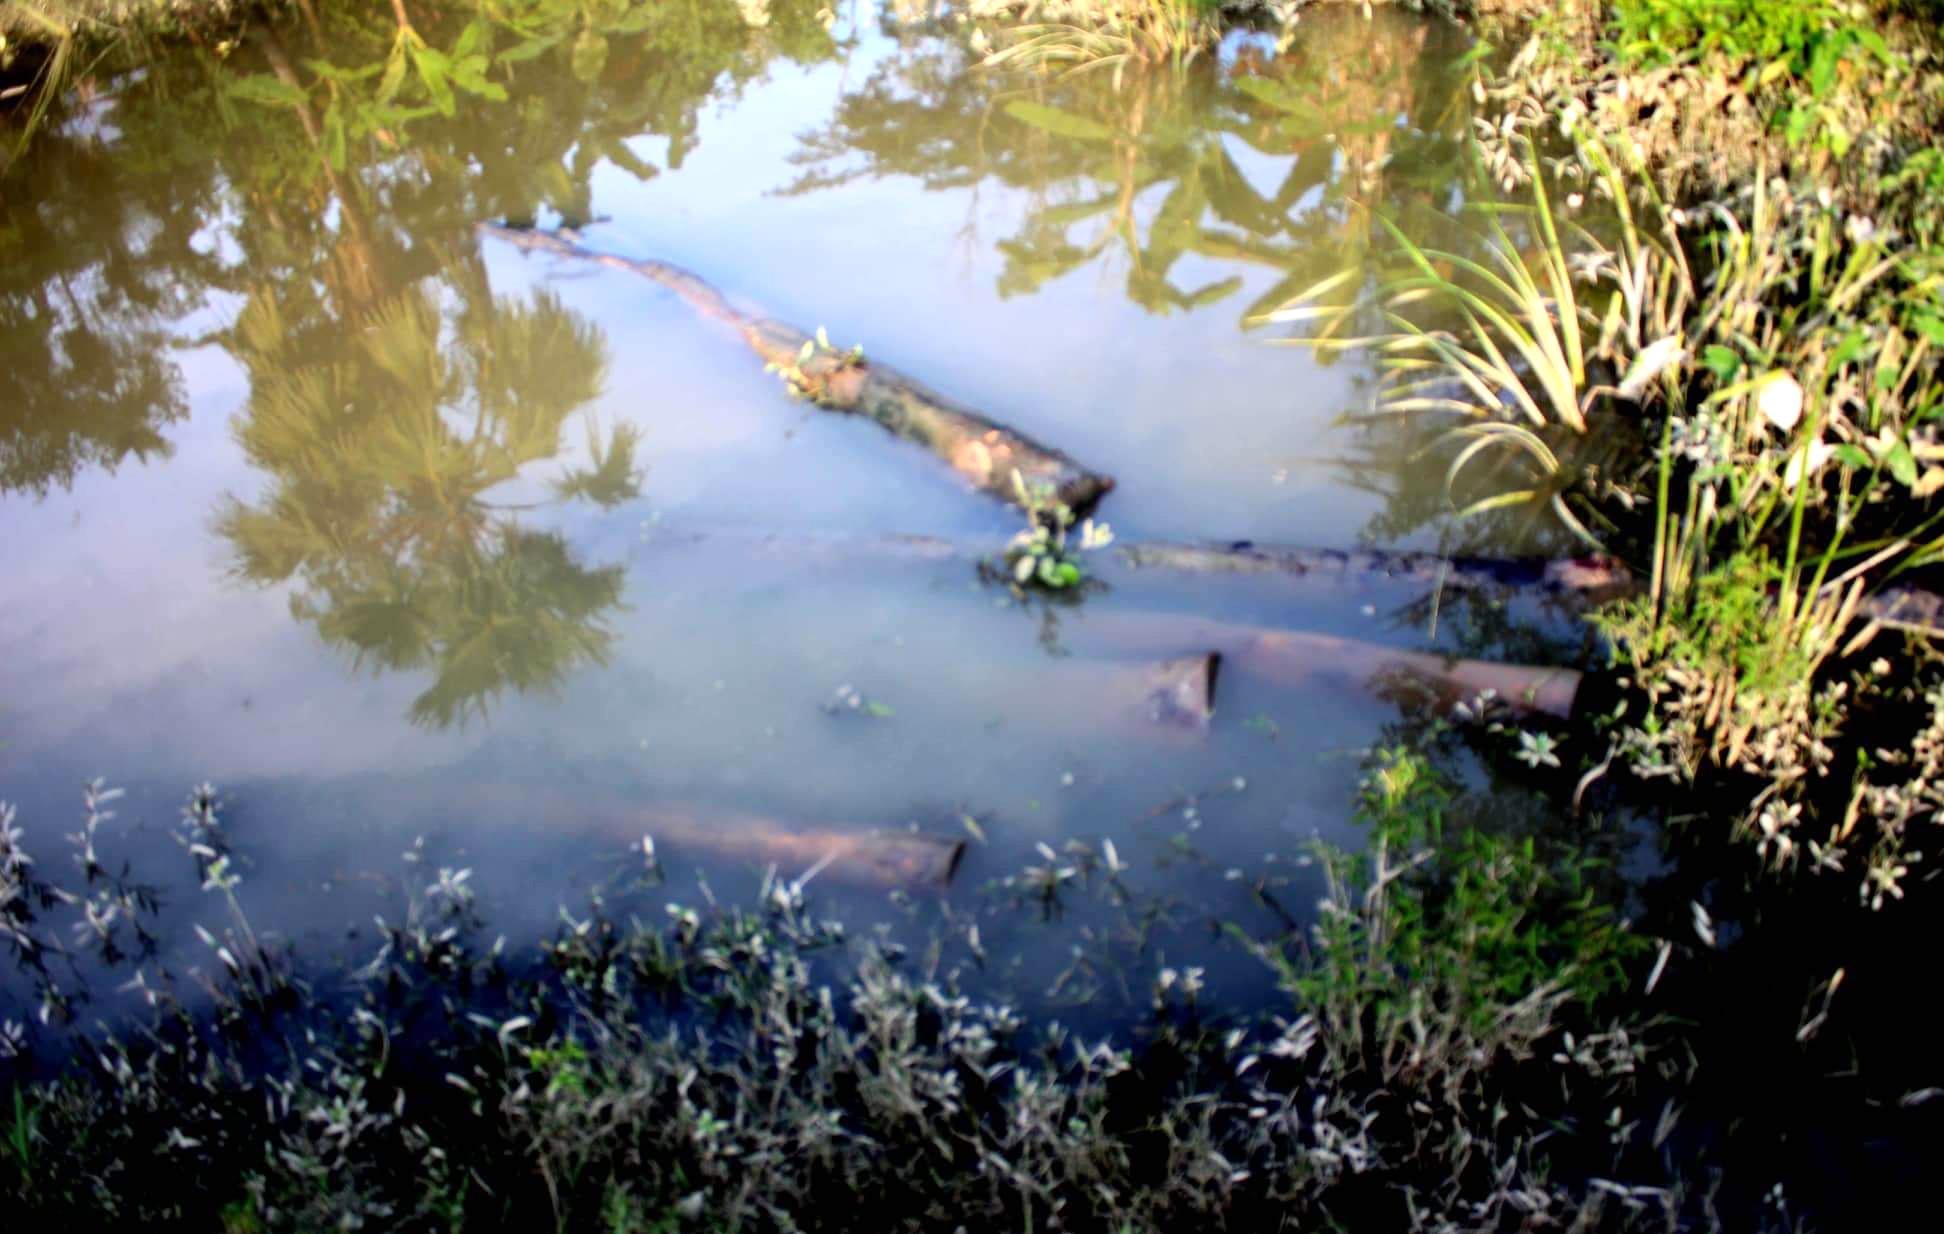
[0,769,1697,1230]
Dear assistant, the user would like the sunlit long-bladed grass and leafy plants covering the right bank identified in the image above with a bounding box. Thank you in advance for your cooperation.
[1269,0,1944,906]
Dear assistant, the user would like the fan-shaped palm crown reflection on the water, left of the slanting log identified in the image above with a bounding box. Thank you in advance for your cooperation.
[218,278,640,727]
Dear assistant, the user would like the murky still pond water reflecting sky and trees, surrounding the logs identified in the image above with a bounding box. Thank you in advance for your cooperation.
[0,0,1570,1026]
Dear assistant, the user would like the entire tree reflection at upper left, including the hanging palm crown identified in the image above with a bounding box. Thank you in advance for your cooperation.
[0,0,840,727]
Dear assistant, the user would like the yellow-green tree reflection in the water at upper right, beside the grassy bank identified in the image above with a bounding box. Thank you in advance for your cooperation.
[783,10,1584,552]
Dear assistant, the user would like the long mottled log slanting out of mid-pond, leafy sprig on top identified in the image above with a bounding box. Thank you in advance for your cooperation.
[478,223,1114,513]
